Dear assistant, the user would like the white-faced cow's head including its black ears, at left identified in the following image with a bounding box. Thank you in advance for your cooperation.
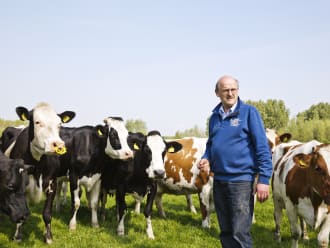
[16,103,75,161]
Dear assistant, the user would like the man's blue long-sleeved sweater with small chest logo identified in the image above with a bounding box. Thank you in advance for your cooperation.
[202,99,273,184]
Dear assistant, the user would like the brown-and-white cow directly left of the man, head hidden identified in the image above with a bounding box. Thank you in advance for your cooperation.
[155,137,213,227]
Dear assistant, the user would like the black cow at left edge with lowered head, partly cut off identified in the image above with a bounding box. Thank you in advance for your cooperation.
[0,152,32,242]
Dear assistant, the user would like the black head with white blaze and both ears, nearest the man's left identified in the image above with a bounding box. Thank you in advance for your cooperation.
[129,131,182,179]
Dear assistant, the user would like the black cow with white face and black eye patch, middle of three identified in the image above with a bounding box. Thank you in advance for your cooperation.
[64,117,133,230]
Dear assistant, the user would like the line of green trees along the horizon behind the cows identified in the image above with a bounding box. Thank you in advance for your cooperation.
[0,99,330,143]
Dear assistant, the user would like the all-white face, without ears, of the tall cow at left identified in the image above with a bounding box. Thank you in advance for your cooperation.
[30,104,66,160]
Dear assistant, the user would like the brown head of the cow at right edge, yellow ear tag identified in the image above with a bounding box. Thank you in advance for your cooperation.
[293,144,330,205]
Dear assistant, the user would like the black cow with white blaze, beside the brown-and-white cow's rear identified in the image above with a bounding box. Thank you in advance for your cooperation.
[101,131,182,239]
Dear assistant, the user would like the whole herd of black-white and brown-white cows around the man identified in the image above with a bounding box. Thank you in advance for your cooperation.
[0,103,330,247]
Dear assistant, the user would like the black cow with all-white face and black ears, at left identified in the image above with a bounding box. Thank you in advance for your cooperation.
[2,103,75,243]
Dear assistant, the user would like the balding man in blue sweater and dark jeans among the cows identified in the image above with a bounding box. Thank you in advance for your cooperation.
[199,76,272,248]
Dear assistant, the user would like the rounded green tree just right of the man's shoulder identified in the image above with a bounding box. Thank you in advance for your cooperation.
[246,99,289,130]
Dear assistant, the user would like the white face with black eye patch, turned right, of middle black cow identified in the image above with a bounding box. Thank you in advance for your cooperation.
[104,117,133,160]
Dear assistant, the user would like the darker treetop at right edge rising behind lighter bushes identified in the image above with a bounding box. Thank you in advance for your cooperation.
[297,102,330,121]
